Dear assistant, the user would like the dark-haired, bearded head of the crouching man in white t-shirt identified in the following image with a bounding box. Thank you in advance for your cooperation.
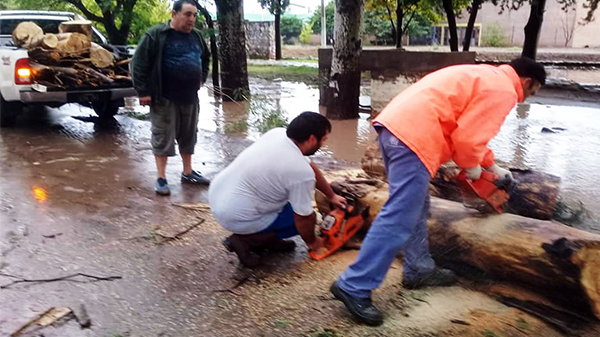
[287,111,331,156]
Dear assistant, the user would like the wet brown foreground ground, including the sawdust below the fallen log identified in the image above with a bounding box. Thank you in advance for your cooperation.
[0,106,600,337]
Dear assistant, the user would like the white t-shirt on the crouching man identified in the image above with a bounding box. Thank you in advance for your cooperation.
[208,128,316,234]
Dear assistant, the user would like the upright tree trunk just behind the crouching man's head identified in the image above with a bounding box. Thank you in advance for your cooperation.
[326,0,364,119]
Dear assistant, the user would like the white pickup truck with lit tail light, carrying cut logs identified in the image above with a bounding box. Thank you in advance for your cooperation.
[0,10,136,126]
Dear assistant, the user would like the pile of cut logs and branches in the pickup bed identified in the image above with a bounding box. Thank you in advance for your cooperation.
[12,21,131,89]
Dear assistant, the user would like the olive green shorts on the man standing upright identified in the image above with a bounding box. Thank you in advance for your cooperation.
[150,98,200,156]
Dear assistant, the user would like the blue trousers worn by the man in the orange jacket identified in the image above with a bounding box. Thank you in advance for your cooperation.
[337,127,435,298]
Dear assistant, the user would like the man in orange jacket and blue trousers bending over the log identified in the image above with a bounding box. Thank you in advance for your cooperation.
[331,58,546,325]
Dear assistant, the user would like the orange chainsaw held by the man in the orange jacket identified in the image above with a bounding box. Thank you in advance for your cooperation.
[456,170,511,213]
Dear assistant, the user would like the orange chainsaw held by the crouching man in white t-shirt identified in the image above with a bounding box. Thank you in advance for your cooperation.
[308,197,367,261]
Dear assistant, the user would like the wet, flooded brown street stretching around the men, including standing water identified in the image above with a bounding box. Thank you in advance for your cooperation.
[0,79,600,337]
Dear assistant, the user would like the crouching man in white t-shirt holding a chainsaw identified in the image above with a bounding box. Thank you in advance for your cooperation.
[208,111,346,268]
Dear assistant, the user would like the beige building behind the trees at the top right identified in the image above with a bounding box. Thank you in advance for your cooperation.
[438,0,600,48]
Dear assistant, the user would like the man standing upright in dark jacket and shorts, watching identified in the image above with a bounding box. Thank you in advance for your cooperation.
[133,0,210,195]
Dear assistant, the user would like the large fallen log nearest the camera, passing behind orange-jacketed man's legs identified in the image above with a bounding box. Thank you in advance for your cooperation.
[316,170,600,318]
